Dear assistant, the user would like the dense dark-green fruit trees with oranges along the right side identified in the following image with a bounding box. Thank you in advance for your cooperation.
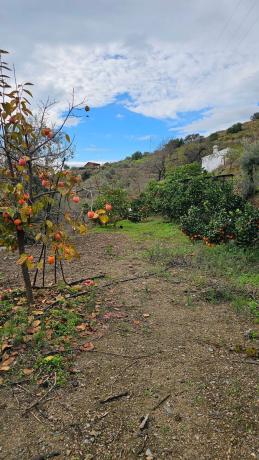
[139,163,259,246]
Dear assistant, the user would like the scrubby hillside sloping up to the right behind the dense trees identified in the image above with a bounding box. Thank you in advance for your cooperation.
[78,120,259,197]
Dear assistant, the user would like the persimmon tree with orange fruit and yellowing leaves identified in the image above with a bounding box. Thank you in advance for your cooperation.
[0,50,89,303]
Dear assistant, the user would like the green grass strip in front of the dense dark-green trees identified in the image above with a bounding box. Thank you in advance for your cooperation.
[94,218,259,287]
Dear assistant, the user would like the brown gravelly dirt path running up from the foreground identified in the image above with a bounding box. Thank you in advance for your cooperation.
[0,234,259,460]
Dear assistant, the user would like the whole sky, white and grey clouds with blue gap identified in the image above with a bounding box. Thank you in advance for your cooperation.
[0,0,259,162]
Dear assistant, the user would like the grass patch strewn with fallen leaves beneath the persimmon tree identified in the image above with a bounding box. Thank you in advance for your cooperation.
[0,285,98,385]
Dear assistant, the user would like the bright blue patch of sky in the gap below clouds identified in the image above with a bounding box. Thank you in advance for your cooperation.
[66,99,211,162]
